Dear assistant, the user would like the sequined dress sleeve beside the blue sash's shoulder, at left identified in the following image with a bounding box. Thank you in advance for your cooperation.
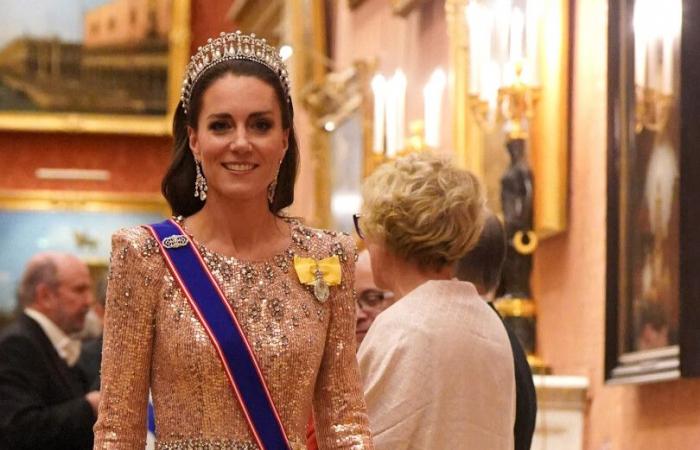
[95,228,162,449]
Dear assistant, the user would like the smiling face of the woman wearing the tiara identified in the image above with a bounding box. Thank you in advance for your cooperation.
[188,73,289,202]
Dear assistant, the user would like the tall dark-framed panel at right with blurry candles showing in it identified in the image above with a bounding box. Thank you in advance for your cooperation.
[605,0,700,383]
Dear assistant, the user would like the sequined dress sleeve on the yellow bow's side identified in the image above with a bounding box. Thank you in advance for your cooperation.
[314,236,374,450]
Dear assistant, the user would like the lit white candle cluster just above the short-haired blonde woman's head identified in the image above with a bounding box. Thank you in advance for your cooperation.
[372,68,447,166]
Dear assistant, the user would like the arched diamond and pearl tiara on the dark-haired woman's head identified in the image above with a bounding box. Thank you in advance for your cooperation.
[180,31,289,114]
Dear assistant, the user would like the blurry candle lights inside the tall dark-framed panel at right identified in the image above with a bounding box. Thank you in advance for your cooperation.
[633,0,682,133]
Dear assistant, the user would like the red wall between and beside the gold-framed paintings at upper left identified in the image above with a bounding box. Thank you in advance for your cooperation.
[0,0,233,193]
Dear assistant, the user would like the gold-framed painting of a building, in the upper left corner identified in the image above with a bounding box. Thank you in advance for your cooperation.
[0,0,190,135]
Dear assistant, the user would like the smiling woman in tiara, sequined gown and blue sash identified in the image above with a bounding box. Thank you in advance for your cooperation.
[95,32,373,449]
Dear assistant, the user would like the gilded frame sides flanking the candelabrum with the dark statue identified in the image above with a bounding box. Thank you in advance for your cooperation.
[445,0,573,238]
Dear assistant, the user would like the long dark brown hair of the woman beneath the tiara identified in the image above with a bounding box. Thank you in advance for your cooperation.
[161,59,299,216]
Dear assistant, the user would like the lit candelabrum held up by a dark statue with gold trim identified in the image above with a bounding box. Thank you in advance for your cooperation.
[465,0,545,371]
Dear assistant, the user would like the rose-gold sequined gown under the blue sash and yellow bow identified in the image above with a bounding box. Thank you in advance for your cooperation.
[95,220,373,450]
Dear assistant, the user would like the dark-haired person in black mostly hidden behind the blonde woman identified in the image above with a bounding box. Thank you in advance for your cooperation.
[456,214,537,450]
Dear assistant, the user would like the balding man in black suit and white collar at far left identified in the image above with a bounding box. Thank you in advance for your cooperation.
[0,253,100,450]
